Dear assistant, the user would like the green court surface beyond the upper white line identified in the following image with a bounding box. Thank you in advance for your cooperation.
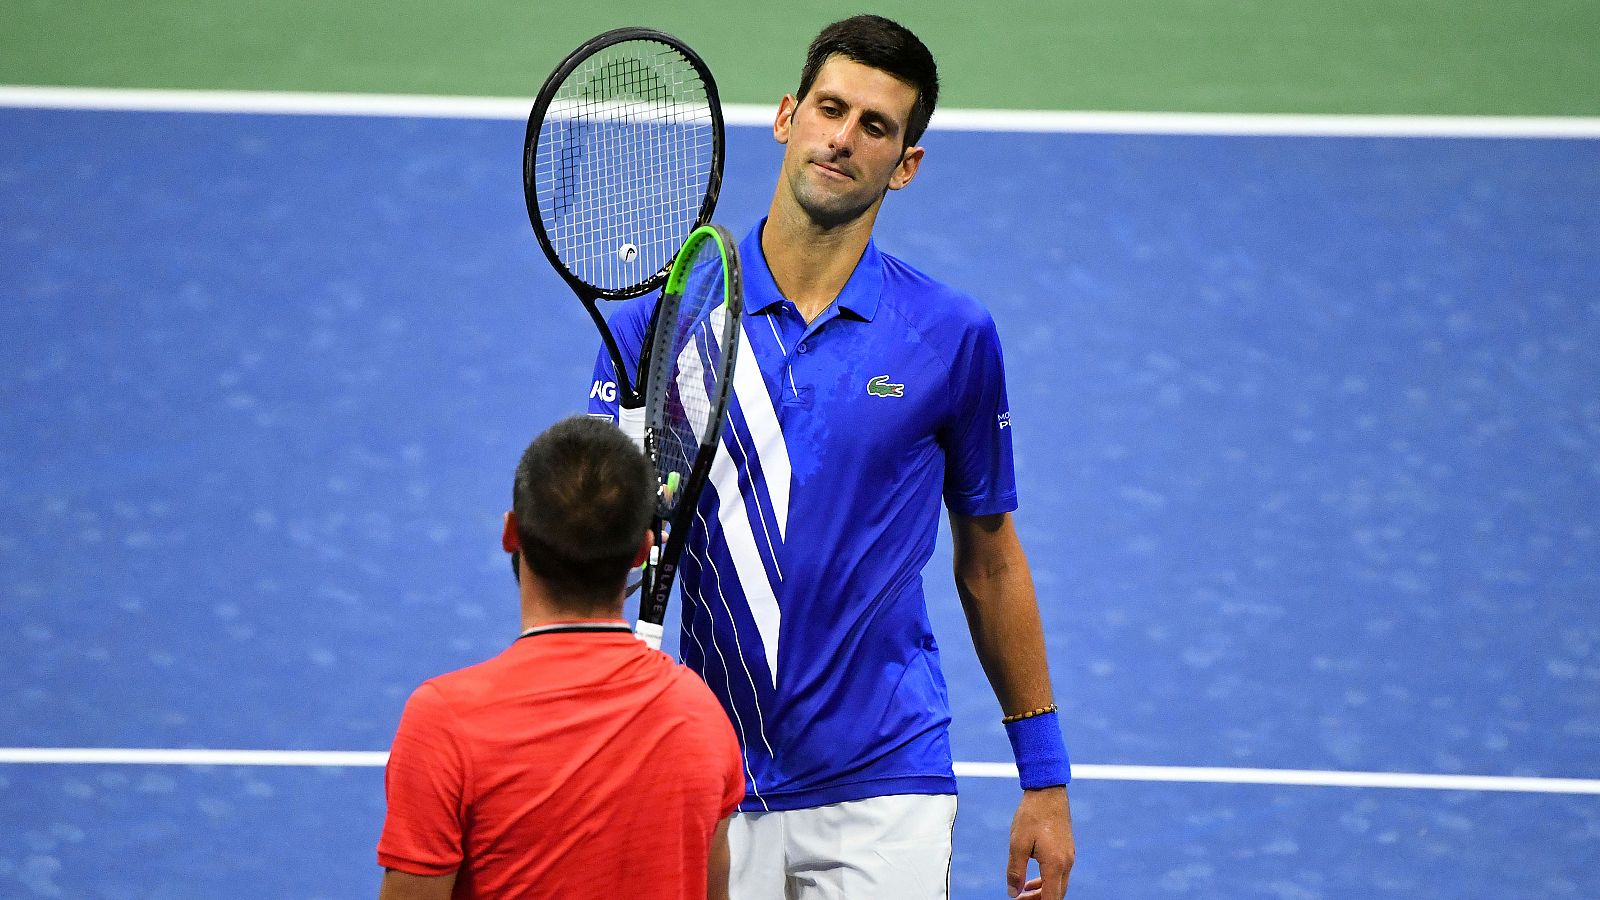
[0,0,1600,115]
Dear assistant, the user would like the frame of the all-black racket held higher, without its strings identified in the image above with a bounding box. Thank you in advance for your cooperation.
[522,26,725,408]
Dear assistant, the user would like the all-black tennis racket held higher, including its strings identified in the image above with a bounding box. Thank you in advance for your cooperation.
[522,27,723,408]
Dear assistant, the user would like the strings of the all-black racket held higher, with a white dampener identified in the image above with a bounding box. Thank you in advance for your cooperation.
[534,40,715,291]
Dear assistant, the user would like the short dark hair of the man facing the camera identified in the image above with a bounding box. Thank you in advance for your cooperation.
[795,16,939,147]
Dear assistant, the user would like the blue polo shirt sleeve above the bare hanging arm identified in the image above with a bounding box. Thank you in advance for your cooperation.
[941,315,1016,516]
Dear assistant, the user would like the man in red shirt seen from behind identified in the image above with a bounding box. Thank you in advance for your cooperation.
[378,416,744,900]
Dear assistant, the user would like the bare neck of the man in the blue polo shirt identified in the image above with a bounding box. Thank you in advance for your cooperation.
[762,197,878,322]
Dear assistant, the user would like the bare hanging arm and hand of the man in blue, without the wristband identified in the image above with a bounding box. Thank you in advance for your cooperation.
[950,512,1077,900]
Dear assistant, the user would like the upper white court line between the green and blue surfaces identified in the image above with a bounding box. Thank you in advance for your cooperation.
[0,85,1600,139]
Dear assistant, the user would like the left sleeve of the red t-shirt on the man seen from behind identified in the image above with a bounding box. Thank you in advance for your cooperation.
[378,684,469,876]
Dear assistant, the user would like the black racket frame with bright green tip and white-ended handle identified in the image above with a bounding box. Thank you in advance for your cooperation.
[637,224,744,649]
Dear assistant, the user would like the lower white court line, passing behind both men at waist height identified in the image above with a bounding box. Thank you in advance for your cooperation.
[0,746,1600,794]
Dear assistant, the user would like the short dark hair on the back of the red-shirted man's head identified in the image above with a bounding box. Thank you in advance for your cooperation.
[512,416,656,609]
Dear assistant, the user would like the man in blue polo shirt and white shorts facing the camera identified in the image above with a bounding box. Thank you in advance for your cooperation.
[590,16,1074,900]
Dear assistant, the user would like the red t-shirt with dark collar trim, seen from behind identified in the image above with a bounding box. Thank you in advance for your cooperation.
[378,631,744,898]
